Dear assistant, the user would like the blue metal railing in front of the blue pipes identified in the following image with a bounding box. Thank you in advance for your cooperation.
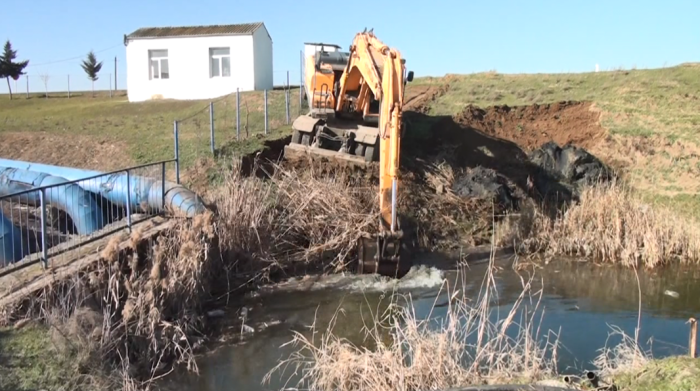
[0,159,179,276]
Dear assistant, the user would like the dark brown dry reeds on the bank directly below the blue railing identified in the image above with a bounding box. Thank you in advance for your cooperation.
[0,213,218,389]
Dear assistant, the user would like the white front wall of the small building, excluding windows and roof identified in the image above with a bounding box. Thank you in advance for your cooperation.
[126,35,258,102]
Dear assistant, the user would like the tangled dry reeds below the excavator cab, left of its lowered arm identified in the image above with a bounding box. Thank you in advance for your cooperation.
[210,158,378,273]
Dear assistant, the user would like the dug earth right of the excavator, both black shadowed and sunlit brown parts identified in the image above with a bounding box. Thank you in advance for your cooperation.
[401,102,605,205]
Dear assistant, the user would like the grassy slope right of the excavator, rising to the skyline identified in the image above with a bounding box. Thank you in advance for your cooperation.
[414,64,700,217]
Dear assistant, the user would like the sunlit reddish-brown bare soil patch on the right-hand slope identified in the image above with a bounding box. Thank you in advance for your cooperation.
[454,101,605,151]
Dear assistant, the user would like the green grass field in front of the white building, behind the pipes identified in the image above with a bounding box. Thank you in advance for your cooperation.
[0,89,299,169]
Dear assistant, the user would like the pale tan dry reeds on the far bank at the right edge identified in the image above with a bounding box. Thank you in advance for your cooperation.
[499,182,700,268]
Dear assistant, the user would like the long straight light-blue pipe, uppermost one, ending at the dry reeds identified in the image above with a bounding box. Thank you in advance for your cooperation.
[0,159,205,217]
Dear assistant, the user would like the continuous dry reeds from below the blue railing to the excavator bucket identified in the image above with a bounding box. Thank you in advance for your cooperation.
[0,158,377,389]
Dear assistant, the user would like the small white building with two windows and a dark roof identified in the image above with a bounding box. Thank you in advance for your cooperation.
[124,23,272,102]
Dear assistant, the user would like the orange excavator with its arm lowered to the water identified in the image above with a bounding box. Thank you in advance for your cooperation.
[284,29,413,277]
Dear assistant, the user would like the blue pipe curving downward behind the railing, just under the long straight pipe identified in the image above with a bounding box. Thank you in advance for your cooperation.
[0,166,105,235]
